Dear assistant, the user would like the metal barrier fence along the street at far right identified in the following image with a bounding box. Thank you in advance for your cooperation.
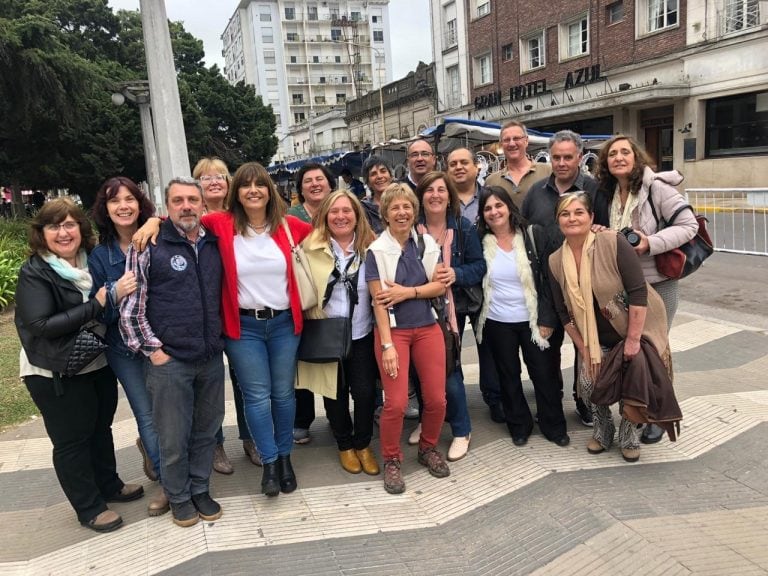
[685,188,768,256]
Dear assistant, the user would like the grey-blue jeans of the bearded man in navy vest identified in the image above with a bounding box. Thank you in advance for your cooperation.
[147,353,224,504]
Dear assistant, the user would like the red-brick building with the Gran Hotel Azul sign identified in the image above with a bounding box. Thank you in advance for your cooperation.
[432,0,768,187]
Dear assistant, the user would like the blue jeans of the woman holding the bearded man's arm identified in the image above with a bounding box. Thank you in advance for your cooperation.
[106,348,160,478]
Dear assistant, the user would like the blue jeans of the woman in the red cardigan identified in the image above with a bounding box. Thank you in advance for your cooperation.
[226,311,299,464]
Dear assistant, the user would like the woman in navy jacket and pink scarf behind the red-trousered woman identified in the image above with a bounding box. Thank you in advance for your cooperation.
[408,172,485,461]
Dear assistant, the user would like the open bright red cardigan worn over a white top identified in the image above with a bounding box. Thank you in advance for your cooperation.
[202,212,312,339]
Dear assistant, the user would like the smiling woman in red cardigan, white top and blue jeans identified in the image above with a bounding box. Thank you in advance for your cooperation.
[203,162,312,496]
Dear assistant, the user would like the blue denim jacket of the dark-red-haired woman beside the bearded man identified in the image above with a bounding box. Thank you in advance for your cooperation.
[88,239,136,357]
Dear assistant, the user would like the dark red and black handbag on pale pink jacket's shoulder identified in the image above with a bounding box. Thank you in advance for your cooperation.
[648,193,715,280]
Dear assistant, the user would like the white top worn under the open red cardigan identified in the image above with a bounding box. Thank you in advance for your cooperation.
[235,231,291,310]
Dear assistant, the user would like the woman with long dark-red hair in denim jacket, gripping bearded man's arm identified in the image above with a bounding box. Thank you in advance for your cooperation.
[88,176,168,516]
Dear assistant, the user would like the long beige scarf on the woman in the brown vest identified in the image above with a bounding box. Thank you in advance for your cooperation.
[563,232,602,378]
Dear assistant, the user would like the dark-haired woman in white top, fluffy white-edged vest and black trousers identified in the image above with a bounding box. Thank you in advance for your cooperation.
[477,186,570,446]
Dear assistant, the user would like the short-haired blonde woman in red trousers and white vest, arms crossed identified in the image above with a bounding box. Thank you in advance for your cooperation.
[365,183,450,494]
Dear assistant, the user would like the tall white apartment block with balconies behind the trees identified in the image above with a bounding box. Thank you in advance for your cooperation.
[221,0,392,161]
